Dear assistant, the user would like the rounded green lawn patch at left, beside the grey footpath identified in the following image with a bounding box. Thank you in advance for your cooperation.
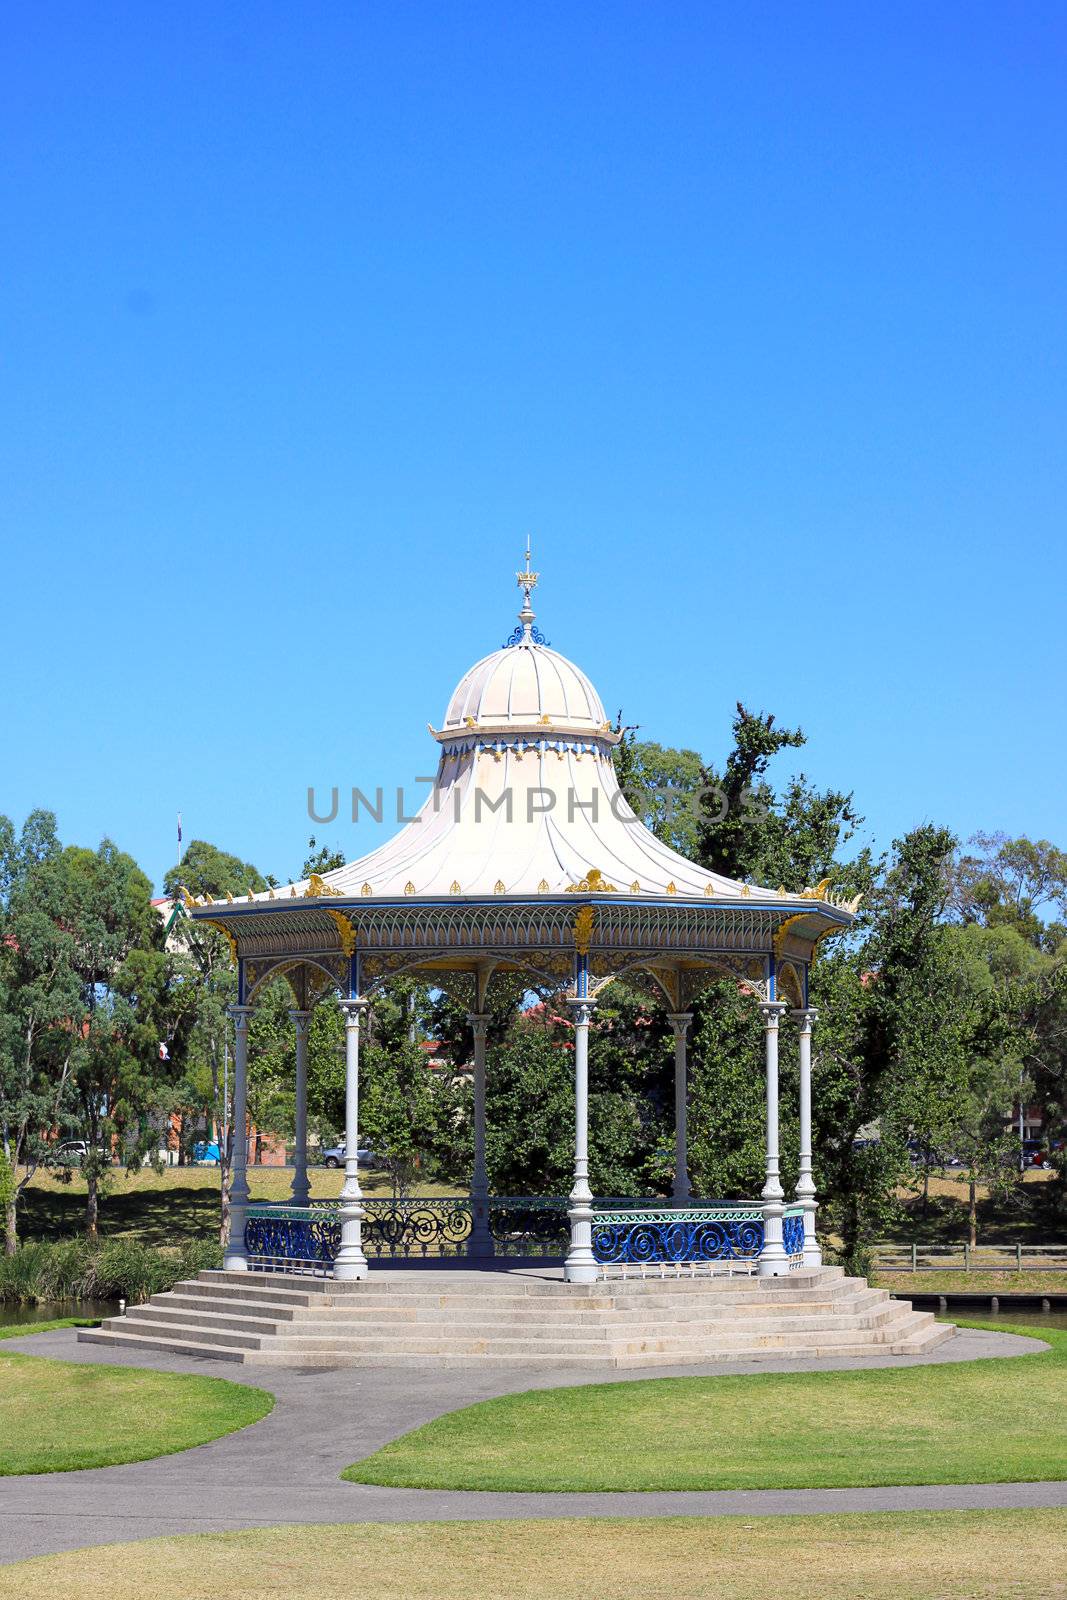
[0,1350,274,1472]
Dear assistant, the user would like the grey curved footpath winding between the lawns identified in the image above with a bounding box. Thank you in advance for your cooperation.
[0,1328,1067,1562]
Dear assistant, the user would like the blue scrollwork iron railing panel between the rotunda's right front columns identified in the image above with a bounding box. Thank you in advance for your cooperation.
[593,1205,763,1266]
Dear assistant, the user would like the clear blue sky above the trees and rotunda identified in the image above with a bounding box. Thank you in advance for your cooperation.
[0,0,1067,882]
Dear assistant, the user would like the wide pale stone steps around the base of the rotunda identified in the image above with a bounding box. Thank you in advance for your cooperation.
[78,1267,955,1368]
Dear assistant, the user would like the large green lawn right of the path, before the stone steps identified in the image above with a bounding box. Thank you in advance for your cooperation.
[342,1323,1067,1491]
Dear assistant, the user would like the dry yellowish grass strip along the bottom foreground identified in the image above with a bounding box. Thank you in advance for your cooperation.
[0,1510,1067,1600]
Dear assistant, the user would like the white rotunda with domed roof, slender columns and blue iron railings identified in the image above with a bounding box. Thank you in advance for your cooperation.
[186,552,854,1282]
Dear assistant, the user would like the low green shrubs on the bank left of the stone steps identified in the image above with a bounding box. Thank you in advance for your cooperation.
[0,1238,222,1306]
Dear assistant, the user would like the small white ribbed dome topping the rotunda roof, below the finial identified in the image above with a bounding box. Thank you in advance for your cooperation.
[442,640,608,733]
